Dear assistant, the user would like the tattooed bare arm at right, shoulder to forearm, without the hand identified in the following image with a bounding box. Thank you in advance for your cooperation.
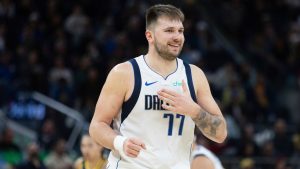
[191,65,227,143]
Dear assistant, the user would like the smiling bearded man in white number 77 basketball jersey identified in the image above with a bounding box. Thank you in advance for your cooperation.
[89,5,227,169]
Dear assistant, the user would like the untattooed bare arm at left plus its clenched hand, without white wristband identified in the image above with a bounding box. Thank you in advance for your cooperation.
[89,62,143,157]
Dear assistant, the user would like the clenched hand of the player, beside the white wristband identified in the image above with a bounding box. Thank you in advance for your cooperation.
[123,138,146,158]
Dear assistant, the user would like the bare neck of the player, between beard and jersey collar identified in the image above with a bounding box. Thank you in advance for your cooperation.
[145,53,177,77]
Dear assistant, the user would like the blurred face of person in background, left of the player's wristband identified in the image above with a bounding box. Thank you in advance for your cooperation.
[80,135,101,160]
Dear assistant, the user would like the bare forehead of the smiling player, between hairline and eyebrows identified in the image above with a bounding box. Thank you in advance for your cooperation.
[156,16,183,29]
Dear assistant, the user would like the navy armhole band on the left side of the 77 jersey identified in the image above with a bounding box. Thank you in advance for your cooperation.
[121,59,142,123]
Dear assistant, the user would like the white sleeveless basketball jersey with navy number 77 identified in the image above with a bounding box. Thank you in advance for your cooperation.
[108,56,196,169]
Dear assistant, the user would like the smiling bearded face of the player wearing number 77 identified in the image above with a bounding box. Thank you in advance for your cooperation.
[153,17,184,60]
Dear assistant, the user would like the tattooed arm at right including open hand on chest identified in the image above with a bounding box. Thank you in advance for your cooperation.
[158,66,227,143]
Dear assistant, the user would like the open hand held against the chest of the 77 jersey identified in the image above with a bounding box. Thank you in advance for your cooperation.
[157,80,201,117]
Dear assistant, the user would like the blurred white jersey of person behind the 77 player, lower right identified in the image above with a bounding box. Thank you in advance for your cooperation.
[192,145,224,169]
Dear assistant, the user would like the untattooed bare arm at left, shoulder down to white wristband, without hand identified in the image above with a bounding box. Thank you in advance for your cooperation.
[89,63,130,149]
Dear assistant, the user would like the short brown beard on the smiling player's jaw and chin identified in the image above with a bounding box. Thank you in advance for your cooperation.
[154,41,182,61]
